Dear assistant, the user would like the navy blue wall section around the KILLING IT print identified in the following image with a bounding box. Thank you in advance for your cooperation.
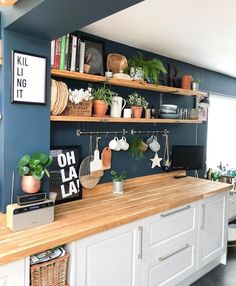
[0,31,50,211]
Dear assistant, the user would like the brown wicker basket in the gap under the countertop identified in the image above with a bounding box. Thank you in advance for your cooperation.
[30,254,69,286]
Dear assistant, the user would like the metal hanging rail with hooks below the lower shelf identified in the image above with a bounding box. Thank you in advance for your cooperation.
[76,129,169,136]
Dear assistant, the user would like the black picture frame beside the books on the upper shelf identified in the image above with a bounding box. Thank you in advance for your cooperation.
[81,36,105,75]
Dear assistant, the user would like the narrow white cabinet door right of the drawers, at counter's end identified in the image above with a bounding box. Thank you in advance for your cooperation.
[198,192,228,269]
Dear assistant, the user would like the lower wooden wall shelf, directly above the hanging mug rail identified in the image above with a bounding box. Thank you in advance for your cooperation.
[50,115,202,124]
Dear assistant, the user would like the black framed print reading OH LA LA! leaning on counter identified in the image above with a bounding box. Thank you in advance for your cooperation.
[49,146,82,204]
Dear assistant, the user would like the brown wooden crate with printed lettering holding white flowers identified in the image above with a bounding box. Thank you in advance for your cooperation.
[62,100,92,116]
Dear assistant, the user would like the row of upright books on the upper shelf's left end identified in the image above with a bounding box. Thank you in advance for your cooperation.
[51,33,85,73]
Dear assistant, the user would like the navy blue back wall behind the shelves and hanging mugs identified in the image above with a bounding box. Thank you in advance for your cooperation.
[51,31,236,182]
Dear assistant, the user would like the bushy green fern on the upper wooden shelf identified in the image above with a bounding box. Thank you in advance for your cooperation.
[128,52,167,84]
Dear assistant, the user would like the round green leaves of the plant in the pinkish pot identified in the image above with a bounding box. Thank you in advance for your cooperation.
[17,152,53,180]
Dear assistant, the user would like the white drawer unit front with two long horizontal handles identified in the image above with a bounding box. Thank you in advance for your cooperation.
[142,203,199,286]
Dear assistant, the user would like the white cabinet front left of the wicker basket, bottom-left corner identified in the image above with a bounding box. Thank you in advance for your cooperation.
[0,259,29,286]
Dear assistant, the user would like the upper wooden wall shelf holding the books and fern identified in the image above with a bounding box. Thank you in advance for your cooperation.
[51,69,207,97]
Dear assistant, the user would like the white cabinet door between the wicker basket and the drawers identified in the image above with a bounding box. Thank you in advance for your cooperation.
[75,224,141,286]
